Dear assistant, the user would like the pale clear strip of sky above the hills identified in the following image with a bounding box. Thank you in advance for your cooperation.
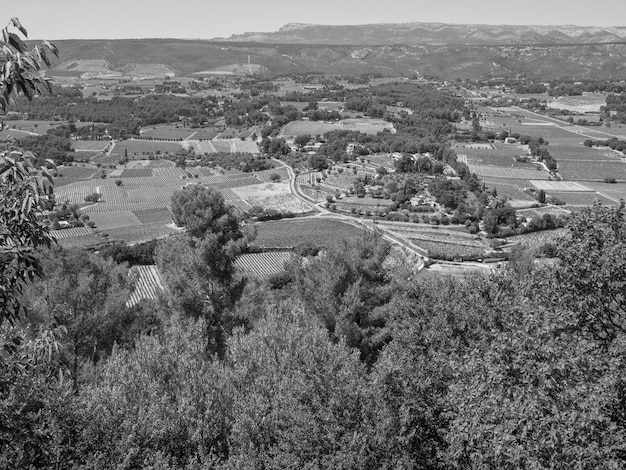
[8,0,626,39]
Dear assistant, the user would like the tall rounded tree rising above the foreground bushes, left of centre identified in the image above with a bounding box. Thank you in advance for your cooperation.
[156,185,249,358]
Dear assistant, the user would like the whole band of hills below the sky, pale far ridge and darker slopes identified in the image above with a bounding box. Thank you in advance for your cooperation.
[49,23,626,81]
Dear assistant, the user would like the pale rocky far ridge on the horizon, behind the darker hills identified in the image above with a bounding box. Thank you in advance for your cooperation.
[227,23,626,46]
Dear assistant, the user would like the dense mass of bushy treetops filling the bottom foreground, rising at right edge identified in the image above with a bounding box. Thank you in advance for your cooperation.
[0,206,626,469]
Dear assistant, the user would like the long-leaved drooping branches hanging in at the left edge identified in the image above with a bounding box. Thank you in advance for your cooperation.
[0,18,58,324]
